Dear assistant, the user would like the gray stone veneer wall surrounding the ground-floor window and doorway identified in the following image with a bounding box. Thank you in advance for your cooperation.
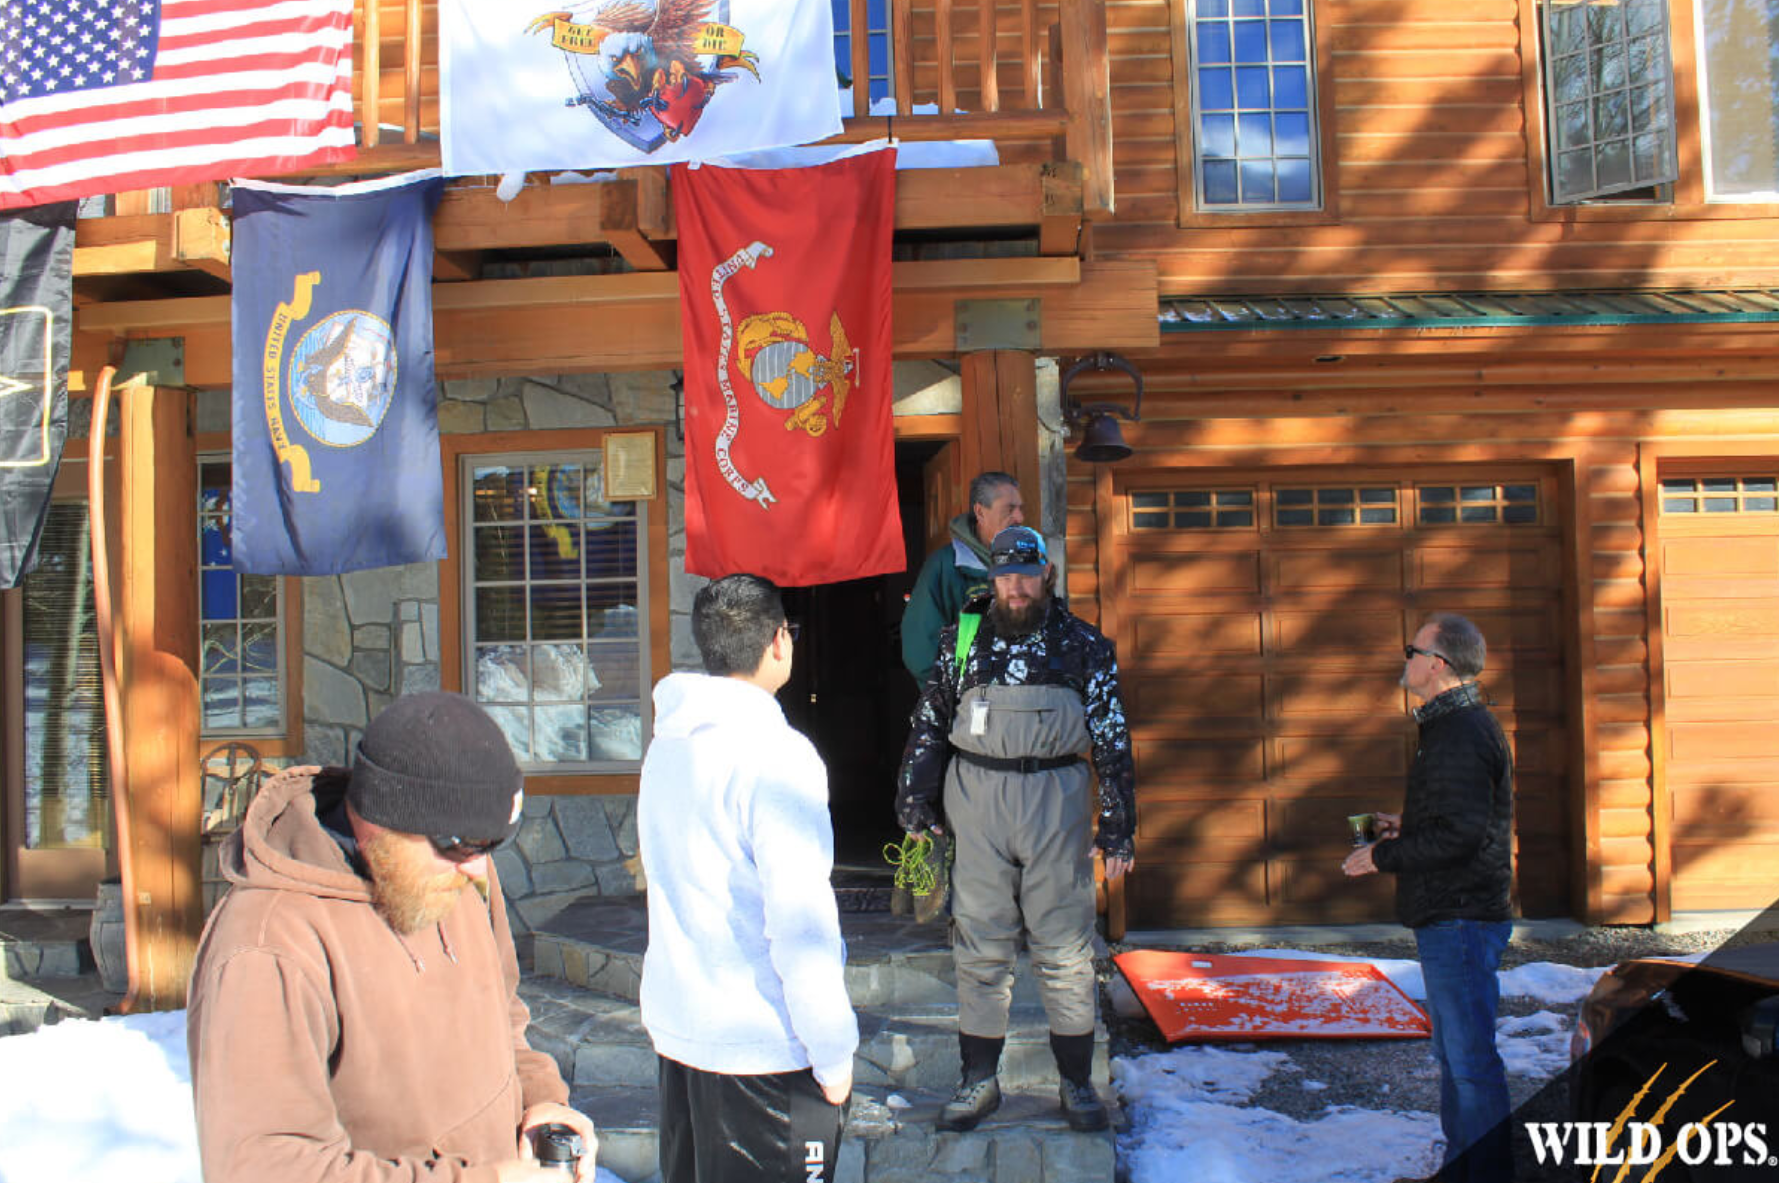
[197,361,1064,932]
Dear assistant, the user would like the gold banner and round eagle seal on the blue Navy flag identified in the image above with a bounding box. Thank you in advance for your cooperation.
[260,270,395,493]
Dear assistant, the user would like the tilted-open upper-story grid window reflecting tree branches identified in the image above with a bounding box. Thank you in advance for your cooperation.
[1542,0,1679,203]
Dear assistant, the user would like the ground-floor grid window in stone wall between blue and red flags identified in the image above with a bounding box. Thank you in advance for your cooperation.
[461,450,651,772]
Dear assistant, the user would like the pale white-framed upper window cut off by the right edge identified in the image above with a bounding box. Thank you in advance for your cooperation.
[1694,0,1779,201]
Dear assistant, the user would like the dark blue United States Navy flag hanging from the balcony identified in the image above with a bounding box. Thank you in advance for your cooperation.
[233,173,445,575]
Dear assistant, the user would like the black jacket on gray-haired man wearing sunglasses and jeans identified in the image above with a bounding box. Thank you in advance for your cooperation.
[1372,683,1514,929]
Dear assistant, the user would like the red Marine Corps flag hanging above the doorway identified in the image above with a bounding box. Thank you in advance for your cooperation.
[672,149,906,587]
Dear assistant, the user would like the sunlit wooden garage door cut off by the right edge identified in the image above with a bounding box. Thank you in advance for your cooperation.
[1660,459,1779,911]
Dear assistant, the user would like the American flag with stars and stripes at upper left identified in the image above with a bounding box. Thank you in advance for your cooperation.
[0,0,356,210]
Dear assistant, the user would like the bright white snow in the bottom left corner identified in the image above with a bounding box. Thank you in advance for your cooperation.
[0,1010,623,1183]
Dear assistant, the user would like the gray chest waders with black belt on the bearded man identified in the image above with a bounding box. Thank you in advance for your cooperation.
[945,685,1094,1039]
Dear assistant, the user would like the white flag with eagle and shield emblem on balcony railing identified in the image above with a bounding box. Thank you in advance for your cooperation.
[439,0,841,176]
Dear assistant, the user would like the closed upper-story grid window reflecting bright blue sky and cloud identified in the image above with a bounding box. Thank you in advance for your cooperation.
[1187,0,1322,213]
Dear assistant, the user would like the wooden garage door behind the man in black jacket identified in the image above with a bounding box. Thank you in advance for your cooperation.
[1112,468,1569,927]
